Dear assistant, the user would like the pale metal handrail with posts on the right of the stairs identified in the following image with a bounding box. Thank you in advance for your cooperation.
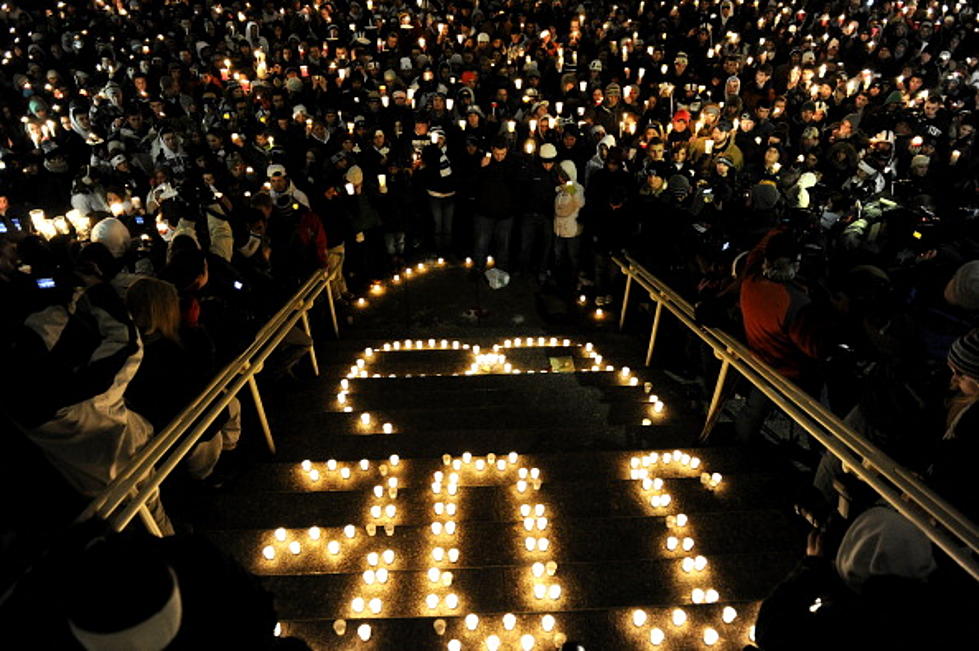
[613,255,979,580]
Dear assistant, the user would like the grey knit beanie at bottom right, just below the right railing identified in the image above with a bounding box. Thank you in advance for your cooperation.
[836,506,935,592]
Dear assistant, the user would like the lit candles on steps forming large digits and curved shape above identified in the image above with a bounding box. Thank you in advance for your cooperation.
[259,336,753,649]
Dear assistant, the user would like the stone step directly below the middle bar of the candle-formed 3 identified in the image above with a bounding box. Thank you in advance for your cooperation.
[255,553,798,620]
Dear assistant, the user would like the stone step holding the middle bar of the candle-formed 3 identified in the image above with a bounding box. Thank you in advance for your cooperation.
[207,500,805,576]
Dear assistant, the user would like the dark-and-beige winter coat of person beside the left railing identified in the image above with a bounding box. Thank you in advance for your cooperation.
[4,283,153,495]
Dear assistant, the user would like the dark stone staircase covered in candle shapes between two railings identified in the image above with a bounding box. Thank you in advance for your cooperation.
[193,331,805,649]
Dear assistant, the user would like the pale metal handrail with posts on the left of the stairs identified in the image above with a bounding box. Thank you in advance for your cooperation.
[78,270,339,536]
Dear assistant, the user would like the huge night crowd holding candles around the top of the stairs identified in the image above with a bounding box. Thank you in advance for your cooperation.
[0,0,979,648]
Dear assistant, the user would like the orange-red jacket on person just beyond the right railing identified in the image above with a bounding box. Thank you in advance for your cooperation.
[741,229,826,379]
